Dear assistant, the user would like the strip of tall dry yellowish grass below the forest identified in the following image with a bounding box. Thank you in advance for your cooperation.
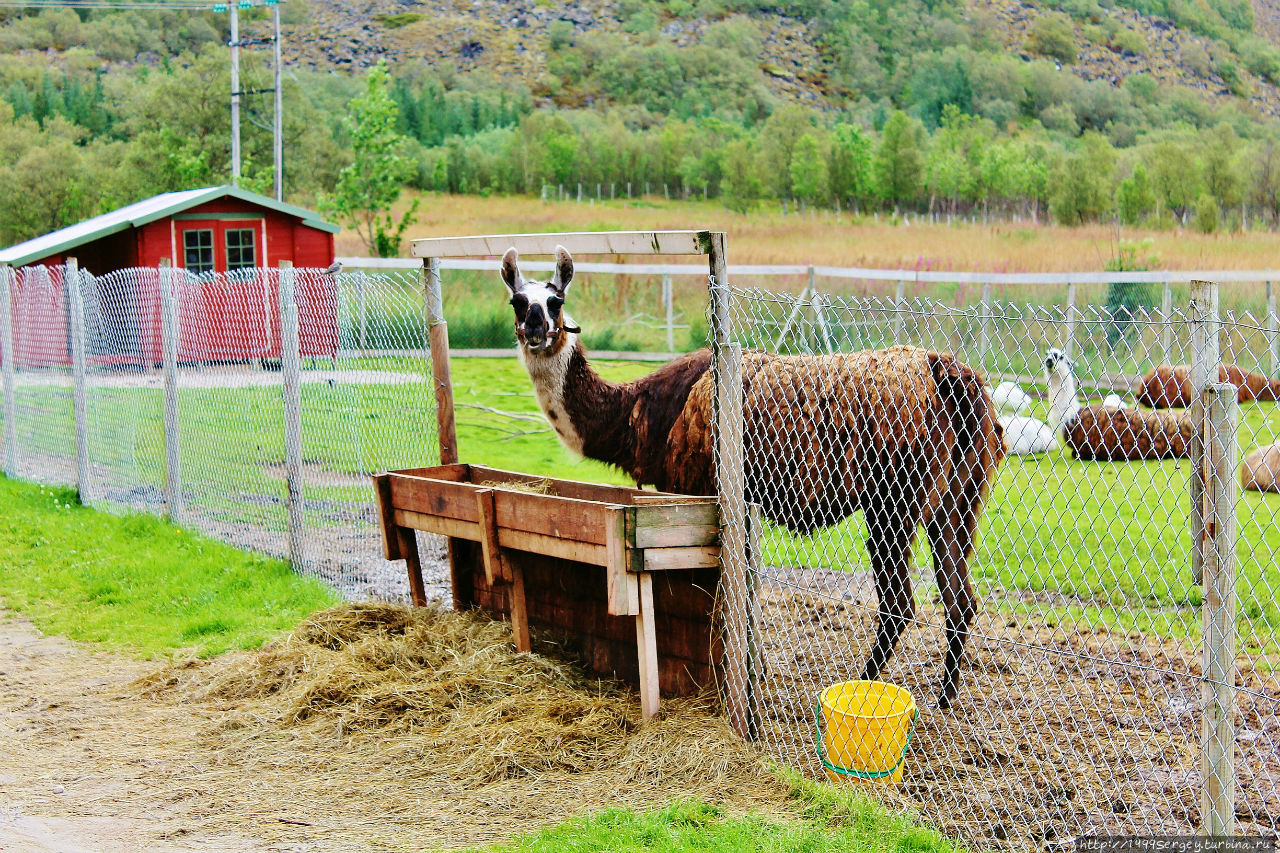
[337,193,1280,273]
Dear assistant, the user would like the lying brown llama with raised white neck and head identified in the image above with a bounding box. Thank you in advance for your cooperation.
[1044,348,1193,462]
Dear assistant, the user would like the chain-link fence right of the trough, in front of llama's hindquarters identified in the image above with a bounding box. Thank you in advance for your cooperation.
[712,282,1280,849]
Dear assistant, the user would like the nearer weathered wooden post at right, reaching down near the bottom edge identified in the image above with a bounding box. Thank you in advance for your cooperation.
[1197,382,1238,835]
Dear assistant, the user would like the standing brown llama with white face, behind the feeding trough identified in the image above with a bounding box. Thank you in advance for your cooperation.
[502,246,1005,708]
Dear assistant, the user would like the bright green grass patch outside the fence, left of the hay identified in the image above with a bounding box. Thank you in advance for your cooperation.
[0,478,337,657]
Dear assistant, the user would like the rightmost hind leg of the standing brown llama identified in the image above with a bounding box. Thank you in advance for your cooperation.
[925,496,977,708]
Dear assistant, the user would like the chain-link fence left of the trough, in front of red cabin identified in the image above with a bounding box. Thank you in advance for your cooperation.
[6,266,439,598]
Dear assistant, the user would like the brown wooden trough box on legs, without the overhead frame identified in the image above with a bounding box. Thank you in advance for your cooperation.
[375,464,719,717]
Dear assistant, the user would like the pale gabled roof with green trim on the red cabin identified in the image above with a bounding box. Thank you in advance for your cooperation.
[0,186,342,266]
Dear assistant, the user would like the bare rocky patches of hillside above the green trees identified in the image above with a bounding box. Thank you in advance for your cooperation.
[272,0,1280,117]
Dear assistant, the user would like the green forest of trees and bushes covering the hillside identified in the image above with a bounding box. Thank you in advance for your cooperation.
[0,0,1280,251]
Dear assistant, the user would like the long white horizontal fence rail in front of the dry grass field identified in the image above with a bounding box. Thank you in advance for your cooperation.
[337,256,1280,284]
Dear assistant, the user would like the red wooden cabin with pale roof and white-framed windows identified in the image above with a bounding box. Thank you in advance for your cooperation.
[0,186,339,366]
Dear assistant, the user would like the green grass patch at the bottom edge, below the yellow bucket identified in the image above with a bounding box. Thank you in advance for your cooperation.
[477,770,957,853]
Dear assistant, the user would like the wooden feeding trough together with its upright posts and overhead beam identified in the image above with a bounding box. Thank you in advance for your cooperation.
[375,231,758,736]
